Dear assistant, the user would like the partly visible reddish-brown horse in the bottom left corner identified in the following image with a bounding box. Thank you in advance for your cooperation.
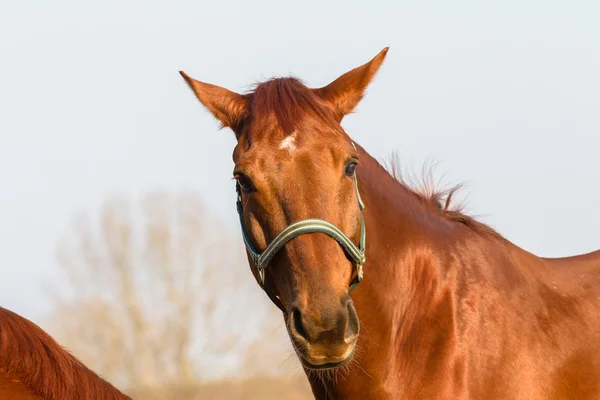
[0,307,131,400]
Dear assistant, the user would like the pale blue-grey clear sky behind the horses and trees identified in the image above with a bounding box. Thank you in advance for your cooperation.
[0,0,600,328]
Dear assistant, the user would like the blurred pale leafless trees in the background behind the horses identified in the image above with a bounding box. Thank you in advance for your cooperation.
[42,192,297,387]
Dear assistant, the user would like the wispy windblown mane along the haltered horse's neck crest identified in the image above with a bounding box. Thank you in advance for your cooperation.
[382,152,505,241]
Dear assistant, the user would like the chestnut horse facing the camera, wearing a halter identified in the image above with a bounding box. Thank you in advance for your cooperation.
[180,48,600,400]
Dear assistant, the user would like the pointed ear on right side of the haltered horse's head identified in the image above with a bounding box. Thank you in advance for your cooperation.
[313,47,389,121]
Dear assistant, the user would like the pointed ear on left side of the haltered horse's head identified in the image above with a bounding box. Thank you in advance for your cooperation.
[179,71,248,136]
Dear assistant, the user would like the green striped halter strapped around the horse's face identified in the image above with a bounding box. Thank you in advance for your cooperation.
[236,143,366,312]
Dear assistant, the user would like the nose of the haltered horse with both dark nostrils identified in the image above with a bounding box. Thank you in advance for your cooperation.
[290,294,359,344]
